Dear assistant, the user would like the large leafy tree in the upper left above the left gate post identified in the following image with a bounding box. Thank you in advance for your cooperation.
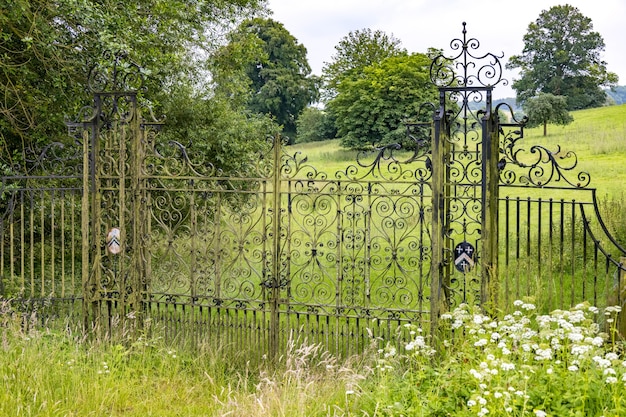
[0,0,263,167]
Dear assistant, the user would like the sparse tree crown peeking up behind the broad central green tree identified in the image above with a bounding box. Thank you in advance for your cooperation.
[322,29,406,99]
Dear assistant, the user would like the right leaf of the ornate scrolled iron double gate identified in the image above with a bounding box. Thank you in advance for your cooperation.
[279,142,431,352]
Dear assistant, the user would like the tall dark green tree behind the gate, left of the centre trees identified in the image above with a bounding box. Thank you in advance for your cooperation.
[216,18,319,139]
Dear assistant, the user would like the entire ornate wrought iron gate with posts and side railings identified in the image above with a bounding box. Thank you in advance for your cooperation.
[0,27,626,355]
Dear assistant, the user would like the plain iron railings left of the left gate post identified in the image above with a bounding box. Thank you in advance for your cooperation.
[0,143,83,321]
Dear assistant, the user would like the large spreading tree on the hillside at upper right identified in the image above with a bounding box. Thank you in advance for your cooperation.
[507,5,617,110]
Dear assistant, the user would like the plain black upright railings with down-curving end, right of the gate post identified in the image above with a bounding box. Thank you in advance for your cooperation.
[500,186,626,311]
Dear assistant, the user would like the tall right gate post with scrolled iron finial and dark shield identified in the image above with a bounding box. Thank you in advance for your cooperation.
[430,22,506,316]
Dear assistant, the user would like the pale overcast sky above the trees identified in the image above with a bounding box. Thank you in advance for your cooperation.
[269,0,626,98]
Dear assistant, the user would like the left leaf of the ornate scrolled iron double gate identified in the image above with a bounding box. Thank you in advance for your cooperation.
[143,136,280,348]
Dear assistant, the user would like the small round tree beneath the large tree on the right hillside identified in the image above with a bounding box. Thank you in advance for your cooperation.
[524,93,574,136]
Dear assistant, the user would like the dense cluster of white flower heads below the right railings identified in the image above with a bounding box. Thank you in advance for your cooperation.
[441,300,626,417]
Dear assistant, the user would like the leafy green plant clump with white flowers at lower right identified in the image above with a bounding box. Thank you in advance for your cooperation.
[356,301,626,417]
